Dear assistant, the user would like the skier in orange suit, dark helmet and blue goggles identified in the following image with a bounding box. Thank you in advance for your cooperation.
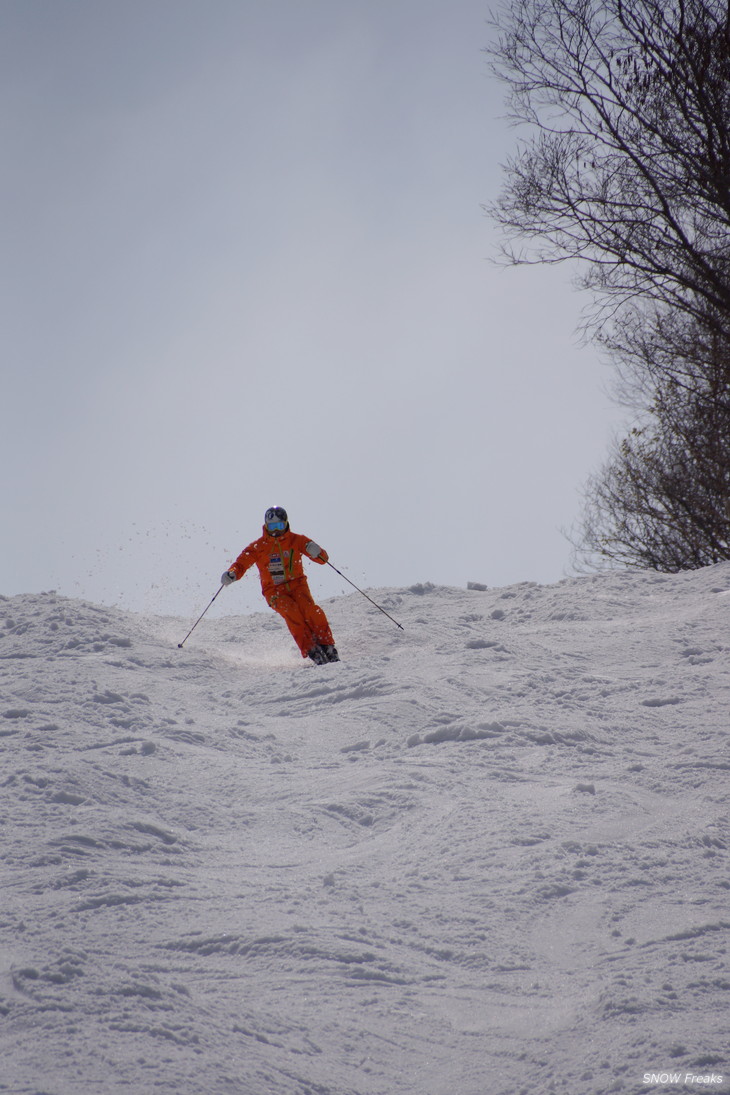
[221,506,339,666]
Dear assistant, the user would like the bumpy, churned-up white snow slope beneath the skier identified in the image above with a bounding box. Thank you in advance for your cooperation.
[0,565,730,1095]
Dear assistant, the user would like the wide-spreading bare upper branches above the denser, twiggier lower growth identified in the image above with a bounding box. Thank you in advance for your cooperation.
[487,0,730,326]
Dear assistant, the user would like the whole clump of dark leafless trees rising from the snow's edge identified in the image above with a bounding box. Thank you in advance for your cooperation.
[489,0,730,570]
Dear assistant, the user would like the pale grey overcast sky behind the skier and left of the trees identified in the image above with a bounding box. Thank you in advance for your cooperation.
[0,0,619,616]
